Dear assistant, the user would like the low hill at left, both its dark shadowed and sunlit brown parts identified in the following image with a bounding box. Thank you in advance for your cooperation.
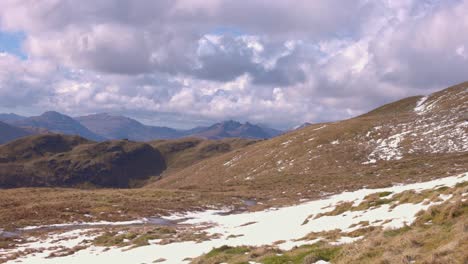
[0,134,256,188]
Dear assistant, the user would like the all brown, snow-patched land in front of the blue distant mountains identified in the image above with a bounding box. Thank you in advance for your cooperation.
[0,83,468,263]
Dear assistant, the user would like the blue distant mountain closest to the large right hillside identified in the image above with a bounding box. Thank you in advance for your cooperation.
[190,120,281,139]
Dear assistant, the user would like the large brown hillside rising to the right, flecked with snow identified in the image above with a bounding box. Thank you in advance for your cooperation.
[153,83,468,203]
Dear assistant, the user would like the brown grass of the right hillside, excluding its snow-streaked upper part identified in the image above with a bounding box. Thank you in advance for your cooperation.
[152,108,468,205]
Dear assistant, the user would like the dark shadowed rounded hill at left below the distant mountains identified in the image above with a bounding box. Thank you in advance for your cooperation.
[0,134,166,188]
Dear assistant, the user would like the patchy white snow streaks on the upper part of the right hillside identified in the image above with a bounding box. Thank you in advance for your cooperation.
[363,88,468,164]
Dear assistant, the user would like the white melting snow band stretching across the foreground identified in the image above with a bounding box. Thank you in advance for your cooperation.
[4,173,468,263]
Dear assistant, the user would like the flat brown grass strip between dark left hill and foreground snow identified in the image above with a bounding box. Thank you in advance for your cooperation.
[0,188,243,229]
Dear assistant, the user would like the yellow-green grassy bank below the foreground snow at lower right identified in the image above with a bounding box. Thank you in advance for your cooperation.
[192,178,468,264]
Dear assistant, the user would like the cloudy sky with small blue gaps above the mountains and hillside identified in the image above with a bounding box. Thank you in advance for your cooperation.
[0,0,468,129]
